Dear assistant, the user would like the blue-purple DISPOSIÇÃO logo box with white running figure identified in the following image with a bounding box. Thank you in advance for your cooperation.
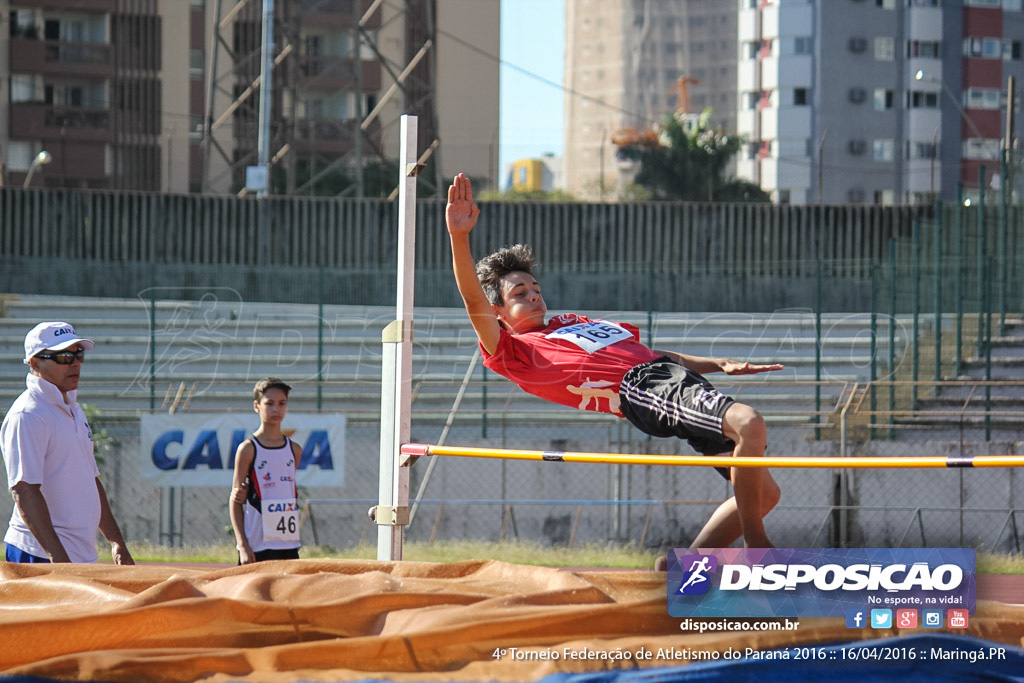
[668,548,975,616]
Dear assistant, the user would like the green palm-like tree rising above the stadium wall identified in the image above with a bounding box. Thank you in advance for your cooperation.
[620,110,770,202]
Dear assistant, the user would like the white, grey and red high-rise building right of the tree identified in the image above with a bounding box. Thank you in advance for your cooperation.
[737,0,1024,204]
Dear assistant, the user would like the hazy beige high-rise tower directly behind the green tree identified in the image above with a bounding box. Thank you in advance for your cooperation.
[564,0,737,199]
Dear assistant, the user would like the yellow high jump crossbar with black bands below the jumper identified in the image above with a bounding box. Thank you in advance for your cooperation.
[401,443,1024,469]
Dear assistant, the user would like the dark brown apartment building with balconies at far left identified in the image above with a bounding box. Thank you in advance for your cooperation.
[0,0,164,190]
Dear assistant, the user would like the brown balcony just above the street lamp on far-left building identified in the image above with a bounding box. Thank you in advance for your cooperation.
[10,102,114,142]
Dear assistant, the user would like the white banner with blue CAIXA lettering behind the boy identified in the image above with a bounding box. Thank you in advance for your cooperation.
[139,413,345,488]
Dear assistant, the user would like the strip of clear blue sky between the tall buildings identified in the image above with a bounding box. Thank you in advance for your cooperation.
[498,0,565,179]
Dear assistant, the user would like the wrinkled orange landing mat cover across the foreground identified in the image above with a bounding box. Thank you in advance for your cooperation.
[0,560,1024,683]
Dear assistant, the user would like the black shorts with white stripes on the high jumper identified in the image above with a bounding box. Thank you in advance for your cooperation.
[618,356,736,479]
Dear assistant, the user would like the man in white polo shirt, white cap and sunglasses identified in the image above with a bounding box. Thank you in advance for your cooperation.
[0,323,135,564]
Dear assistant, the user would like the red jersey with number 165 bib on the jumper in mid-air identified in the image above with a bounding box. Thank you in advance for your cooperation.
[480,313,660,417]
